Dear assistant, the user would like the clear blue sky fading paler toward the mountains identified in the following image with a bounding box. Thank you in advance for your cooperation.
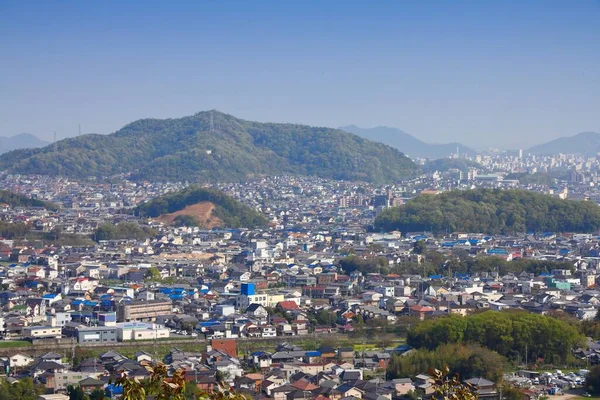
[0,0,600,148]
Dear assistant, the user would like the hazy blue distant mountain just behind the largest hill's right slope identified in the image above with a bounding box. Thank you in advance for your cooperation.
[340,125,477,159]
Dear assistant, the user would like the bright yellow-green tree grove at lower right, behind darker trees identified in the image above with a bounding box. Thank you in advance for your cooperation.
[407,311,584,364]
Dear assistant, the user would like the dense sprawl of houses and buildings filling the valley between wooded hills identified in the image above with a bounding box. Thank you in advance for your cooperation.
[0,171,600,400]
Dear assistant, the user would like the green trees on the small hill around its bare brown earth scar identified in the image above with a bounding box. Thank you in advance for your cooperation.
[134,187,267,228]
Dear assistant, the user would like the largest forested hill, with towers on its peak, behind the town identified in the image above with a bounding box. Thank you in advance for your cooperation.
[0,111,417,183]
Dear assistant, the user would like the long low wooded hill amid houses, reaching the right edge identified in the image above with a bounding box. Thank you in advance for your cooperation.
[375,189,600,234]
